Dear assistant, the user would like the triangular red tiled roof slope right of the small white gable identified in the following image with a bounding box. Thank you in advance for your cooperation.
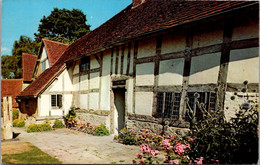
[43,39,69,66]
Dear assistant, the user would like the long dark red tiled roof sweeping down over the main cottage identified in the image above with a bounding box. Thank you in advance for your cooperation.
[17,0,255,96]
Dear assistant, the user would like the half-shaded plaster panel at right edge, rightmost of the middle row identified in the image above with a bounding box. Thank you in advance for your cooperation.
[227,48,259,83]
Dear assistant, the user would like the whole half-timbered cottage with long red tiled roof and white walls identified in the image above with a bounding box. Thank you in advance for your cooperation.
[18,0,259,133]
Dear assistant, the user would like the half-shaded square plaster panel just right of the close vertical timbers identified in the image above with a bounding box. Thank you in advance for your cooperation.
[136,63,154,86]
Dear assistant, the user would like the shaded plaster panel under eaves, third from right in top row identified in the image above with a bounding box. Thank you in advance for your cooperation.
[161,32,186,54]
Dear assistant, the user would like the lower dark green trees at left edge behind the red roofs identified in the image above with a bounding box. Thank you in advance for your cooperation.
[1,36,39,78]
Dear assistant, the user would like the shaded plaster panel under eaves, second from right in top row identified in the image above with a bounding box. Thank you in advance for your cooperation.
[192,28,223,48]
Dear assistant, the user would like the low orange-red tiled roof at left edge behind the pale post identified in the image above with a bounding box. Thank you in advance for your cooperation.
[1,79,23,107]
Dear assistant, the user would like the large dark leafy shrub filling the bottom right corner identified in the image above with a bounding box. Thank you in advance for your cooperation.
[186,91,259,164]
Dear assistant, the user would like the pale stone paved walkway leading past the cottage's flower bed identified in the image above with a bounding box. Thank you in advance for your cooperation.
[10,128,139,164]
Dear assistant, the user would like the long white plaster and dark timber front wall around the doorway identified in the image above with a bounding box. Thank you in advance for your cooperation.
[72,12,259,132]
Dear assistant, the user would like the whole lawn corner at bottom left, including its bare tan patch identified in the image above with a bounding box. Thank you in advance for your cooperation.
[1,143,62,164]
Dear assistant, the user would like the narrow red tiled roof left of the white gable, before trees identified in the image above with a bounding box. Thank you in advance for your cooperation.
[22,53,37,81]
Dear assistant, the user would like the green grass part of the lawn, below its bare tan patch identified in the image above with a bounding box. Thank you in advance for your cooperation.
[2,143,62,164]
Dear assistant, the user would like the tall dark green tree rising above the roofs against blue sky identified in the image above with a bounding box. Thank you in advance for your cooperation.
[34,8,90,44]
